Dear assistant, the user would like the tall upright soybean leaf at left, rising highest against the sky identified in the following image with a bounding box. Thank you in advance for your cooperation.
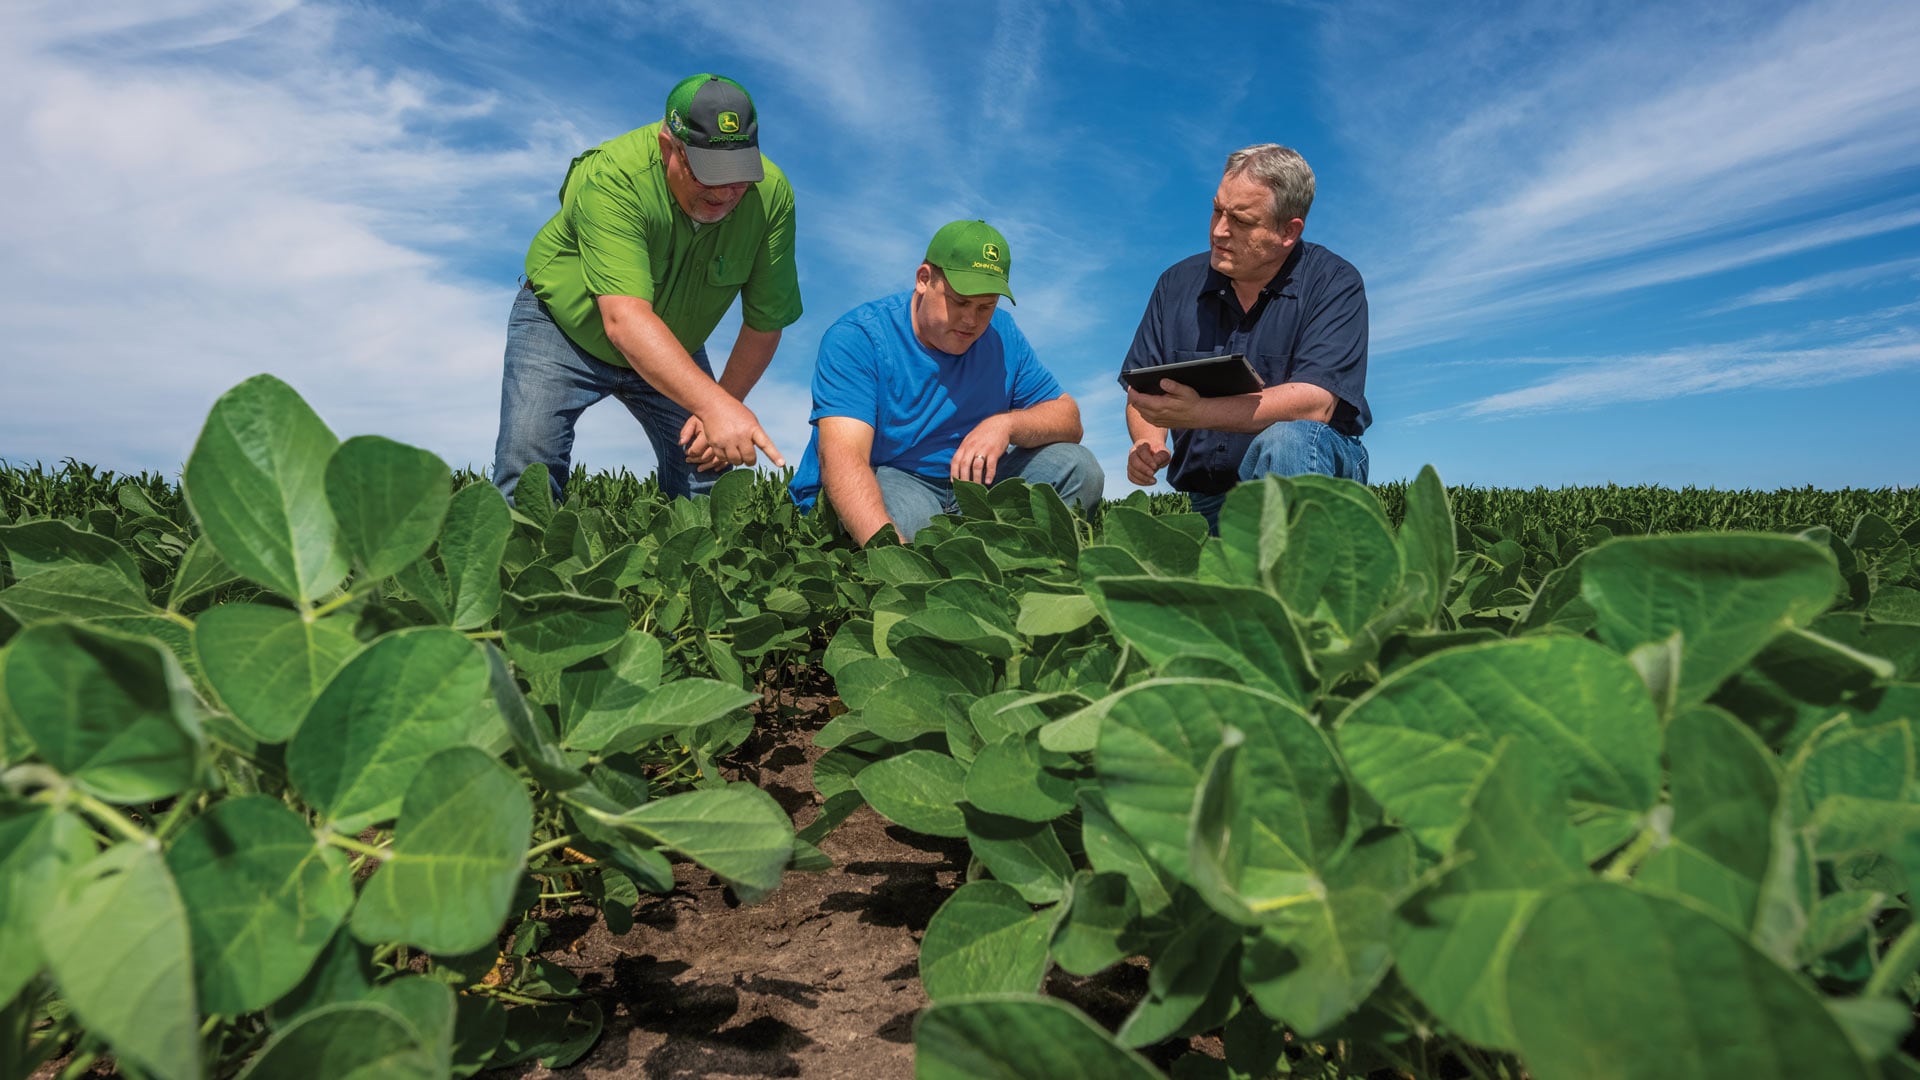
[180,375,348,603]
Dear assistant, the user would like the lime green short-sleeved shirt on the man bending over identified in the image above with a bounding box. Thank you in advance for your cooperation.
[526,123,801,367]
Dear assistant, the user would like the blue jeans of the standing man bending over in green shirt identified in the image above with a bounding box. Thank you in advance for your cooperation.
[493,288,720,502]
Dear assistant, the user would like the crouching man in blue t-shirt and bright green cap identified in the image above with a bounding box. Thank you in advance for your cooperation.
[789,221,1106,544]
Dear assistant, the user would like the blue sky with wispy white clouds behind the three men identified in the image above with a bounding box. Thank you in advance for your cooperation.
[0,0,1920,498]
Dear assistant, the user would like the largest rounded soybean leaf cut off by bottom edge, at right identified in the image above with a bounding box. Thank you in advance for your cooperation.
[1507,882,1876,1080]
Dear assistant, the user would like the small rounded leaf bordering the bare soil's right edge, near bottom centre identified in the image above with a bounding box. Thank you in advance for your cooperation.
[920,882,1052,1001]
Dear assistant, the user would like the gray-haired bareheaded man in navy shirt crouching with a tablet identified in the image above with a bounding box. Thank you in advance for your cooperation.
[1121,142,1373,530]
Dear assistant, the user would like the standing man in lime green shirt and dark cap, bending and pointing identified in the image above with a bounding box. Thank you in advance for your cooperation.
[493,75,801,498]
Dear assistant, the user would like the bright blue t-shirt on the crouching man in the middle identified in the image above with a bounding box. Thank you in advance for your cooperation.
[787,290,1064,509]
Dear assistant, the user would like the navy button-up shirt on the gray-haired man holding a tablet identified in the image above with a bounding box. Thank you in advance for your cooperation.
[1121,240,1373,494]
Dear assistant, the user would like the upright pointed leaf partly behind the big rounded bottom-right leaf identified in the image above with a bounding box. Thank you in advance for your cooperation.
[1392,738,1588,1049]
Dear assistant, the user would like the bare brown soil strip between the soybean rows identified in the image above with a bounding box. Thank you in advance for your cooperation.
[486,672,968,1080]
